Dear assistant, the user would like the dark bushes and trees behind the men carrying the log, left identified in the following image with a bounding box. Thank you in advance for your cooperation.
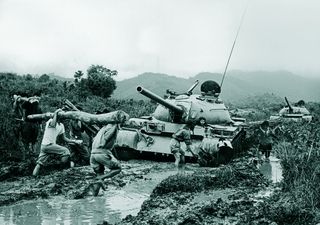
[0,65,155,160]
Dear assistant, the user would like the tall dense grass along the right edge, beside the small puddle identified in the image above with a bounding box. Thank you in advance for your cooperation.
[270,119,320,224]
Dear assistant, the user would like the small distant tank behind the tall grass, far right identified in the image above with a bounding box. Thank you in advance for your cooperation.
[270,97,312,122]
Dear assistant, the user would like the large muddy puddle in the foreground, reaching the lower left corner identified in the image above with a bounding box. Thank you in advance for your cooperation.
[0,170,175,225]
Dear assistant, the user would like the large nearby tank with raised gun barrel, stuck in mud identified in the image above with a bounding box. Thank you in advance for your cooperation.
[114,80,245,162]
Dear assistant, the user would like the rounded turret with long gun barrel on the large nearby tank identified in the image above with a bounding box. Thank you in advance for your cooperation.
[137,81,233,125]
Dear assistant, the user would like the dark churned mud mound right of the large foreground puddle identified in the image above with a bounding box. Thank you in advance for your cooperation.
[118,158,276,225]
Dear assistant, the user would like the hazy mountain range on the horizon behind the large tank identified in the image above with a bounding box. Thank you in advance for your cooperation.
[113,71,320,102]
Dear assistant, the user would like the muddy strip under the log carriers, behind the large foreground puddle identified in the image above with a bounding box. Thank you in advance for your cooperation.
[0,161,174,206]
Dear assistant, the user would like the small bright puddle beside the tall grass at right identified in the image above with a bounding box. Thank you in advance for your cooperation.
[259,156,283,183]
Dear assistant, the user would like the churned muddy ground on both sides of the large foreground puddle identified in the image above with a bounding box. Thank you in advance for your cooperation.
[0,156,316,225]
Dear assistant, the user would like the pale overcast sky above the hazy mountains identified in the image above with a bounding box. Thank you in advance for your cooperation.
[0,0,320,79]
